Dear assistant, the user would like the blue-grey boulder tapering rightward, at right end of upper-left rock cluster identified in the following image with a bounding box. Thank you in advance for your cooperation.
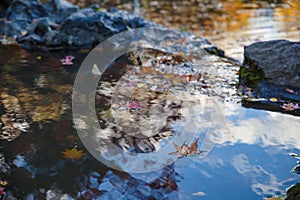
[60,9,146,47]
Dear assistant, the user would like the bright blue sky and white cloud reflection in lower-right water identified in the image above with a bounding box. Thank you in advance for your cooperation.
[175,105,300,200]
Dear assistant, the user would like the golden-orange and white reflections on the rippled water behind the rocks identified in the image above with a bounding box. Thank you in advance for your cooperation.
[73,0,300,61]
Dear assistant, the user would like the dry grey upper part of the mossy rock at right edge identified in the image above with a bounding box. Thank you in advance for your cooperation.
[243,40,300,88]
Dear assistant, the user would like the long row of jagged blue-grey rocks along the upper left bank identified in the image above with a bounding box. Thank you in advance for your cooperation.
[0,0,224,57]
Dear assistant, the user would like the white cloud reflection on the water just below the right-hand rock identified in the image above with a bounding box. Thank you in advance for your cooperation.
[218,104,300,149]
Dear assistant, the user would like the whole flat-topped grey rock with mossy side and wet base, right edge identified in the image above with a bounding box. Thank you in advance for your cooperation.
[240,40,300,116]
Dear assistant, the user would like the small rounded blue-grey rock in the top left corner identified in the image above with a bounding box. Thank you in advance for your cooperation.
[5,0,47,21]
